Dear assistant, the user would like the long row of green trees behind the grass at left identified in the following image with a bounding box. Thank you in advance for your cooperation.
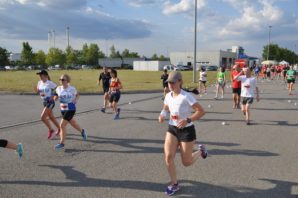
[0,42,167,68]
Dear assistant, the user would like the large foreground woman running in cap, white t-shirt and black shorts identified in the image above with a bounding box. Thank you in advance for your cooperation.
[159,71,208,195]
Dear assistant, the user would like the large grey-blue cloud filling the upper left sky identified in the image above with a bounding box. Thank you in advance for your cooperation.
[0,0,151,40]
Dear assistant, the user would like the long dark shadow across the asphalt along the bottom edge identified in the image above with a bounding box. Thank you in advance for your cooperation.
[0,165,298,198]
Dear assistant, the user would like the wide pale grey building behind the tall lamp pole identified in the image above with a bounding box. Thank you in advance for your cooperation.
[170,50,237,68]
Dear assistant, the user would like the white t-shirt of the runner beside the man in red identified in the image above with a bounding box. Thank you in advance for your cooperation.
[238,75,257,98]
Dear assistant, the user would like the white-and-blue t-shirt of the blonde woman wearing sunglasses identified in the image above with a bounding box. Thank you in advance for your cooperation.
[56,86,77,111]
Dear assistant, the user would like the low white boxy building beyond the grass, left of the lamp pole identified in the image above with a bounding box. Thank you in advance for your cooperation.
[133,61,170,71]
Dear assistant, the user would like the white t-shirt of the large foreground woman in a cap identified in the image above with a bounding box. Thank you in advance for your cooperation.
[164,90,197,127]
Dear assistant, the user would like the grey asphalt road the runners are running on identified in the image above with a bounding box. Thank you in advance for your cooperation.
[0,81,298,198]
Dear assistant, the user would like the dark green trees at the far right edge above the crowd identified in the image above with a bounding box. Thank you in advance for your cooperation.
[262,43,298,64]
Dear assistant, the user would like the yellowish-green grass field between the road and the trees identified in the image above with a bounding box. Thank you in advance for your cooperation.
[0,70,224,93]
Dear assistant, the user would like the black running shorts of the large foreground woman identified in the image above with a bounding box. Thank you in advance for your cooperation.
[168,125,197,142]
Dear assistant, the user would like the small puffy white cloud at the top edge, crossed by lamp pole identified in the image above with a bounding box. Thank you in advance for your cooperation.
[163,0,206,15]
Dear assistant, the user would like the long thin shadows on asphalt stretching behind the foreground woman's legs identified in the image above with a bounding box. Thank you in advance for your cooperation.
[65,134,279,157]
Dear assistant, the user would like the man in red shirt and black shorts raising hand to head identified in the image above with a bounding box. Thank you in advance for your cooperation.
[231,64,241,109]
